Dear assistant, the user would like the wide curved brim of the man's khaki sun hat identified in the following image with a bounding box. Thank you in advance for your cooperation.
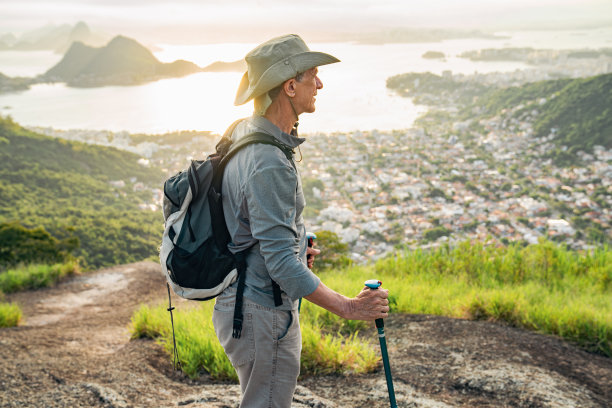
[234,51,340,106]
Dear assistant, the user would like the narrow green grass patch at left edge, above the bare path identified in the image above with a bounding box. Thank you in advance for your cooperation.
[0,261,79,293]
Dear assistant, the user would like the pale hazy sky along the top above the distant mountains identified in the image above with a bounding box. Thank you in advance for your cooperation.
[0,0,612,42]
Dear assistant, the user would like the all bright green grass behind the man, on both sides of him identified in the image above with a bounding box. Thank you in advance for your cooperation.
[132,237,612,379]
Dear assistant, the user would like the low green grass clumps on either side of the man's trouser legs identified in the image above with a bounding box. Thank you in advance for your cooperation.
[131,301,379,381]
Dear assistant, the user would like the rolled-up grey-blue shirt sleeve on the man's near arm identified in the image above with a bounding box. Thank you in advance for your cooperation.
[244,165,320,299]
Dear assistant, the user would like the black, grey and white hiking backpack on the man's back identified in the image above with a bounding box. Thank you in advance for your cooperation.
[160,120,293,346]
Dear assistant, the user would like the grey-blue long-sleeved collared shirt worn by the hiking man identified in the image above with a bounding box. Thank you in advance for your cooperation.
[222,116,320,310]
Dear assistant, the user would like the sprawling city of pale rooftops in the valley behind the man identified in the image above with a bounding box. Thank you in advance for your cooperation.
[32,93,612,263]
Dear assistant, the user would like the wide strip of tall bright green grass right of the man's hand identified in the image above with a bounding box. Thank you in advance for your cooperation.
[346,241,612,357]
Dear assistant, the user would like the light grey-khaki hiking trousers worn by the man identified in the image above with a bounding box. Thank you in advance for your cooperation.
[213,290,302,408]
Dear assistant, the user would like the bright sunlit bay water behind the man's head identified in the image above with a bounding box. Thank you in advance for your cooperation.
[0,29,612,133]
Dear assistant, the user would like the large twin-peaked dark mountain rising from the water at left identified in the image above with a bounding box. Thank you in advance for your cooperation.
[43,36,201,87]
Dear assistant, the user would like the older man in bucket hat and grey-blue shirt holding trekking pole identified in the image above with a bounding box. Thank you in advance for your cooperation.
[213,35,389,408]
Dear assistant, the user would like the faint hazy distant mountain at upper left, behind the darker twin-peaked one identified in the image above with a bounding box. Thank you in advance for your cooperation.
[10,21,106,53]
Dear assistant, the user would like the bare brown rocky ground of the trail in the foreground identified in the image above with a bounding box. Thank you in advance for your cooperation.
[0,262,612,408]
